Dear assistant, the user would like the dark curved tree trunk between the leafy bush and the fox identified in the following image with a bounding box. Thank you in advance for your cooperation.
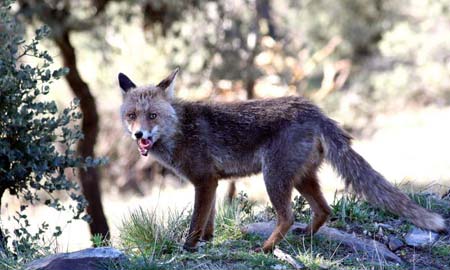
[54,31,110,239]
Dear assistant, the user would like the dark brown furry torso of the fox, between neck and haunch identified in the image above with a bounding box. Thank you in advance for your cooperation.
[174,97,323,177]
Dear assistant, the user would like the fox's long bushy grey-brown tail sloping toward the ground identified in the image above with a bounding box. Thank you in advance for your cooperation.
[322,119,446,232]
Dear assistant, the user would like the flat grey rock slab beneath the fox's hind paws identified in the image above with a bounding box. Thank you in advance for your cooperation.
[241,222,402,263]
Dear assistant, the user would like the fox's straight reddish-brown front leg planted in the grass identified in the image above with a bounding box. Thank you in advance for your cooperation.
[183,180,217,251]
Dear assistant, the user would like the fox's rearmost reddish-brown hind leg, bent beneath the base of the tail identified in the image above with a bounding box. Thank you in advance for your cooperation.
[294,169,331,234]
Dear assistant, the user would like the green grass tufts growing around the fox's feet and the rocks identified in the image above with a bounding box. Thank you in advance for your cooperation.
[0,191,450,270]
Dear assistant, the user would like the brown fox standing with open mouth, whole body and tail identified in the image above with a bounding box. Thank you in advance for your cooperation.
[118,68,447,252]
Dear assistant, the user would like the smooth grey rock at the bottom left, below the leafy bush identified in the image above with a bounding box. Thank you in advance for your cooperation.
[25,247,127,270]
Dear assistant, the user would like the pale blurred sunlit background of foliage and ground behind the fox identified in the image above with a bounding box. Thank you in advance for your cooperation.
[4,0,450,251]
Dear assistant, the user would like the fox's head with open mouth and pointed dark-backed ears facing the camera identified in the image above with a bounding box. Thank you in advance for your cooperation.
[118,68,179,156]
